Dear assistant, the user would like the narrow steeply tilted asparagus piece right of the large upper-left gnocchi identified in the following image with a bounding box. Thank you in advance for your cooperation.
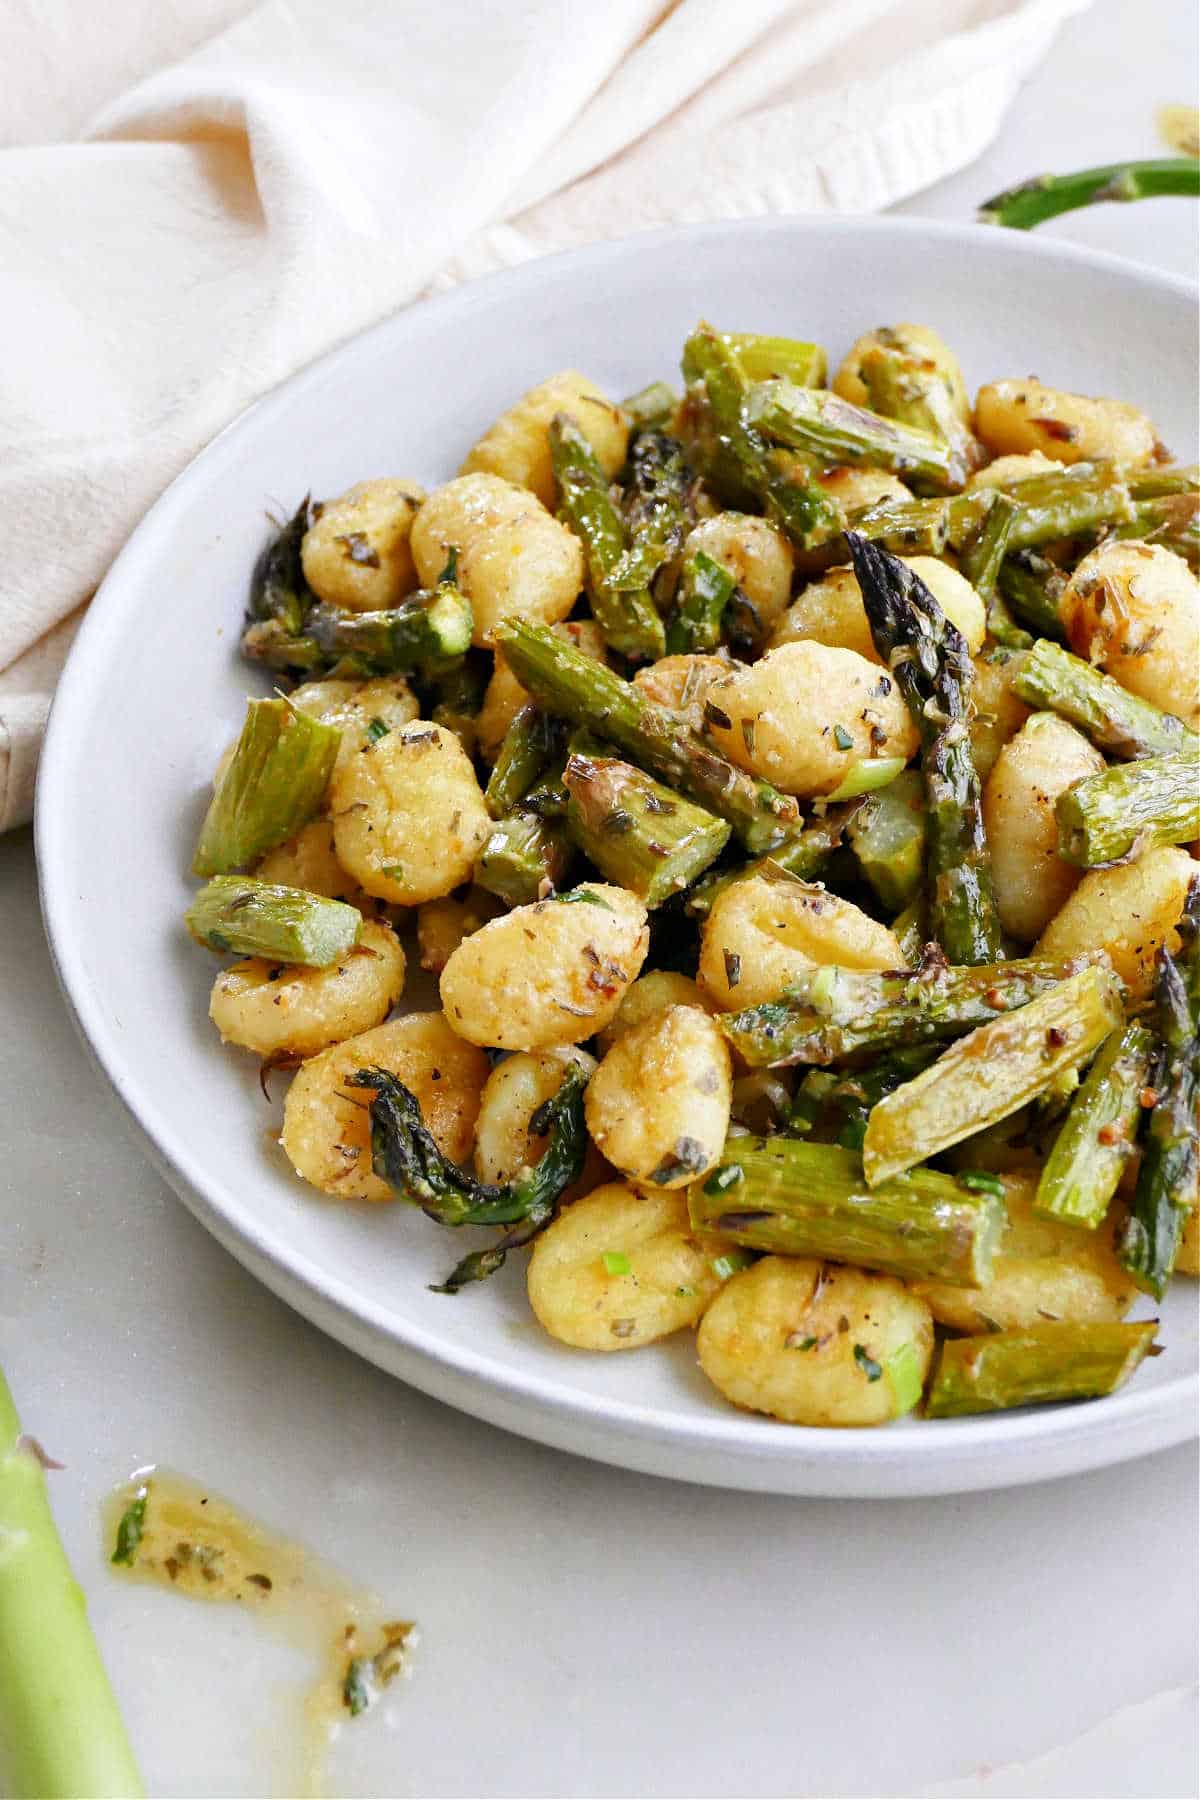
[551,412,666,662]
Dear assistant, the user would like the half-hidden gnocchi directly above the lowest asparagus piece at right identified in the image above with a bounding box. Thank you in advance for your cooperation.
[912,1172,1137,1332]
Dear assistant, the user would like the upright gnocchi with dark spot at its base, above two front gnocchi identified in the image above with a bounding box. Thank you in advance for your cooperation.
[583,1006,732,1188]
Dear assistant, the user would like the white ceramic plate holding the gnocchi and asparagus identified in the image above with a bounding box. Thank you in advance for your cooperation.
[38,218,1196,1496]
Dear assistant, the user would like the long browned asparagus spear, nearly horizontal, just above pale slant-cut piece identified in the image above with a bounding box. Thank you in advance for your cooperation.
[718,945,1078,1069]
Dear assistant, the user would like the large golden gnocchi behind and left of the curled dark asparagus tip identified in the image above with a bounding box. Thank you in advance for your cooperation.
[281,1013,488,1201]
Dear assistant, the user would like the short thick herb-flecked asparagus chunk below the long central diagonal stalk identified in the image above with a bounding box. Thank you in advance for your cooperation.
[563,754,730,907]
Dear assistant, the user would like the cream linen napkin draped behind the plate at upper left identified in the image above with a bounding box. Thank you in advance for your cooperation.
[0,0,1088,830]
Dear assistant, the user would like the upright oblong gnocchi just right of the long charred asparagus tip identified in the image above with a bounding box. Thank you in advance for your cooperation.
[984,713,1105,943]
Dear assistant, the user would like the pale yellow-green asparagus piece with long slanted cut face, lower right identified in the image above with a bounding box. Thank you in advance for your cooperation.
[862,968,1123,1188]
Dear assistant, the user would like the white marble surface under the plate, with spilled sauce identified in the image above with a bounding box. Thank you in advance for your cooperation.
[0,0,1196,1800]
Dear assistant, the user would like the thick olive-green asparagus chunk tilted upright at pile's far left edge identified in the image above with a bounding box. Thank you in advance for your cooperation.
[193,700,342,875]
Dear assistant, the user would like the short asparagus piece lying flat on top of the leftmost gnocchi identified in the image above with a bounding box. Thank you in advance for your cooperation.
[184,875,362,968]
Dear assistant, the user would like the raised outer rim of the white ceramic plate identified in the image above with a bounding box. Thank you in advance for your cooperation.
[34,212,1200,1498]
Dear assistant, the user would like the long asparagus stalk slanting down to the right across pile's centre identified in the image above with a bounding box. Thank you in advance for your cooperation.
[497,617,799,855]
